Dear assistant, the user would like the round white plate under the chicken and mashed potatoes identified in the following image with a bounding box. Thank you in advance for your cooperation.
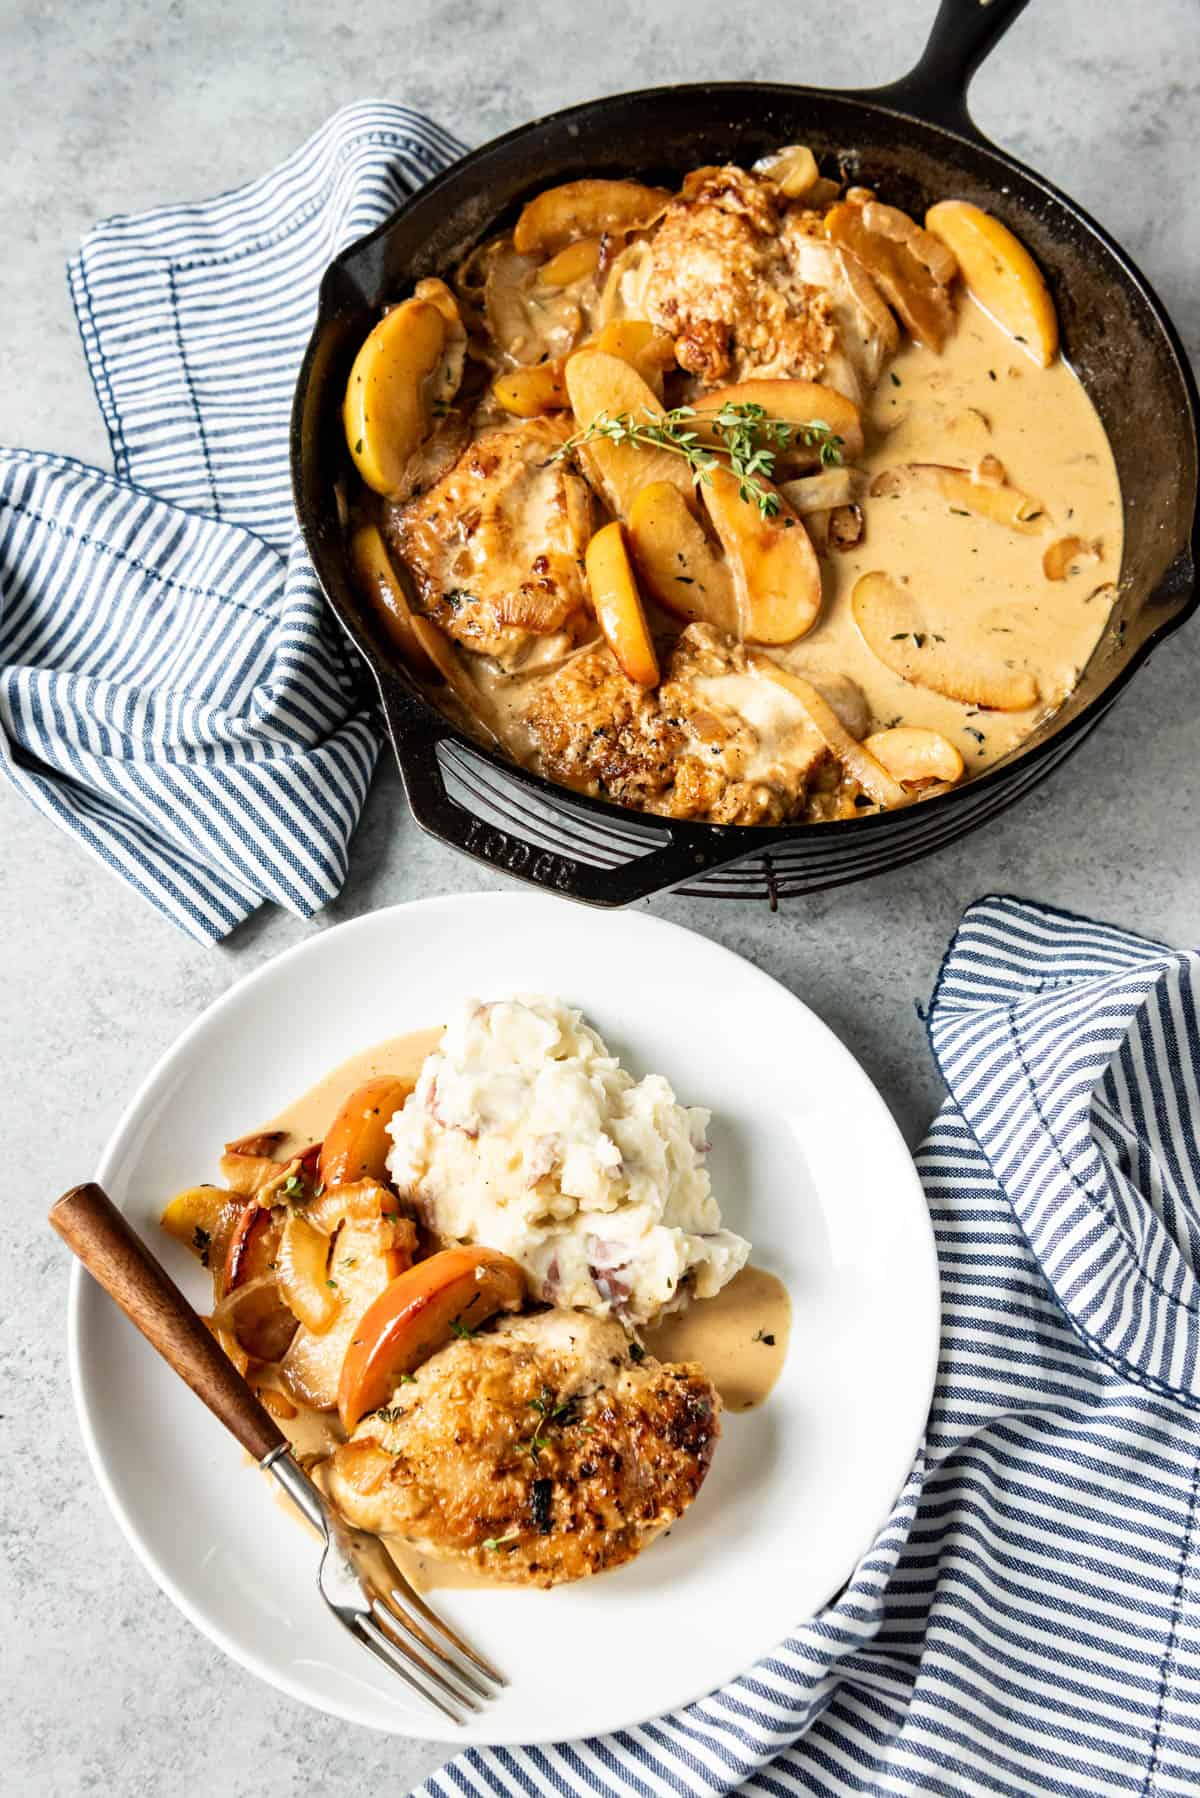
[70,895,939,1742]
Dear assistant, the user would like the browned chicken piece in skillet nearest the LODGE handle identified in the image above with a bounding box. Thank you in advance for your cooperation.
[525,624,858,823]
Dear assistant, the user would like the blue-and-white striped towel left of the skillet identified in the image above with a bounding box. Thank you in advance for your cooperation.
[0,102,462,942]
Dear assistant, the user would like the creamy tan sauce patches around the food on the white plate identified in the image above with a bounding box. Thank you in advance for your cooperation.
[263,1028,792,1591]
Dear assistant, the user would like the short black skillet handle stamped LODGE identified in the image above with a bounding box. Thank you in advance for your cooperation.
[380,674,744,906]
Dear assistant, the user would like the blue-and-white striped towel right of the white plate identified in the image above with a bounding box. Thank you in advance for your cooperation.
[425,899,1200,1798]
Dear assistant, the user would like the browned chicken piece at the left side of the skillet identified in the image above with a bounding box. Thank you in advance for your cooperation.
[389,419,592,665]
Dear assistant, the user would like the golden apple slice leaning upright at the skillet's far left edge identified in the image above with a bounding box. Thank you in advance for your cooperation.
[342,298,461,496]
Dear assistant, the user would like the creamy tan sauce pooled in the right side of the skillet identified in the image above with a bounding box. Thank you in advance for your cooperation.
[775,297,1123,773]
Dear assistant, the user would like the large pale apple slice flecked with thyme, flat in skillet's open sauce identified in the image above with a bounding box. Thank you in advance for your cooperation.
[851,572,1038,712]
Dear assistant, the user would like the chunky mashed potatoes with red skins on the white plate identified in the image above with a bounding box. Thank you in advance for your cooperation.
[389,998,750,1325]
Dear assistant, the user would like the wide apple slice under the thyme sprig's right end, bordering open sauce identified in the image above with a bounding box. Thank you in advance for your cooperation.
[700,467,820,644]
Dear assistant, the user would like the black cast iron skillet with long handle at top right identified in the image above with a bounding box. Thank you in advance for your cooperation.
[291,0,1200,906]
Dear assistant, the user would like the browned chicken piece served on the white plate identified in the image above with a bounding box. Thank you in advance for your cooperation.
[327,1311,721,1586]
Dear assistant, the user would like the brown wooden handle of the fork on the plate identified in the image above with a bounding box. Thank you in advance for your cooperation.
[50,1181,288,1460]
